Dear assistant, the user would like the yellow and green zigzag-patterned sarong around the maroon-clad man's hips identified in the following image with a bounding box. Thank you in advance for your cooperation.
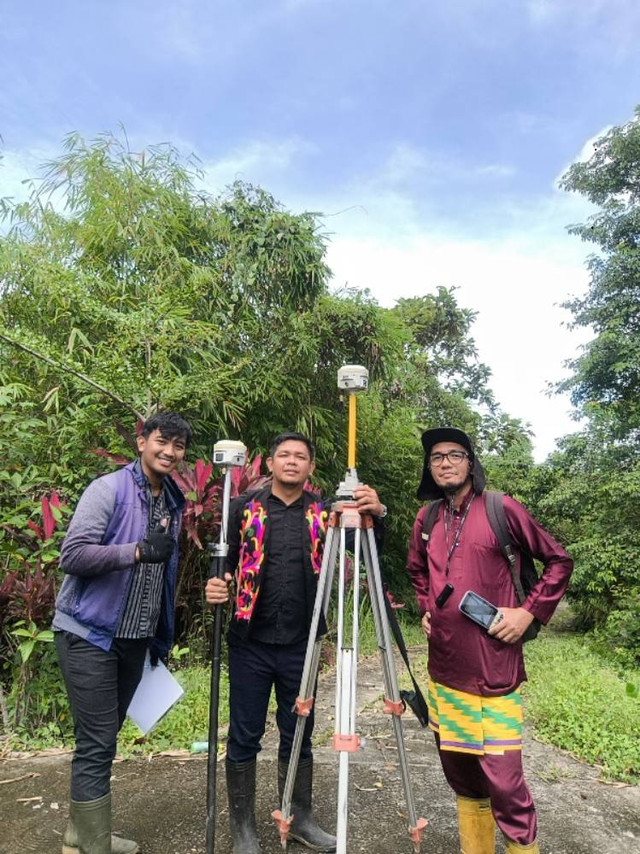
[427,677,522,755]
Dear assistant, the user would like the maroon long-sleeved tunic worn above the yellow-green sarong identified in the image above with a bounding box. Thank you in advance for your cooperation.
[407,495,573,696]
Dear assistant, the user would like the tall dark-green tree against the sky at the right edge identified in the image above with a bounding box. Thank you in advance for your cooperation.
[561,108,640,442]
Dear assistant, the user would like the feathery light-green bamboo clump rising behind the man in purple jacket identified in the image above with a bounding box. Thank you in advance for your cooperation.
[0,136,327,462]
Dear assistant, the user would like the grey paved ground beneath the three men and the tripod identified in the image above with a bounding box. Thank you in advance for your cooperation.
[0,659,640,854]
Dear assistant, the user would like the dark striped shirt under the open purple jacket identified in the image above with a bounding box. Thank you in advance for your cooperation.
[115,484,169,638]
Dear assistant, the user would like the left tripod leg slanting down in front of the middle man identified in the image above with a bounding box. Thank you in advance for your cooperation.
[271,527,338,849]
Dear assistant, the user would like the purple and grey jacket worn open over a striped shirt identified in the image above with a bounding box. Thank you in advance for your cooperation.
[53,461,185,656]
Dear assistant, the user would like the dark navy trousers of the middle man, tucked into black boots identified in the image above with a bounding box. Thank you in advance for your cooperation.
[227,637,313,762]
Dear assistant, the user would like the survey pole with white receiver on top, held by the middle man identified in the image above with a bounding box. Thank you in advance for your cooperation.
[205,440,247,854]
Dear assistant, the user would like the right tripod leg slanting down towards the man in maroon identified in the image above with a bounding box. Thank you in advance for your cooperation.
[362,528,427,852]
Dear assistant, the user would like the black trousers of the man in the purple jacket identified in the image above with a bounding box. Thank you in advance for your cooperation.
[55,632,149,801]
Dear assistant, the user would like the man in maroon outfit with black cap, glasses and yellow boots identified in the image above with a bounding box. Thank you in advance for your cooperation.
[407,427,573,854]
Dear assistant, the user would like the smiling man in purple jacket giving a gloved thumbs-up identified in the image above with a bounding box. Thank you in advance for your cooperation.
[53,412,191,854]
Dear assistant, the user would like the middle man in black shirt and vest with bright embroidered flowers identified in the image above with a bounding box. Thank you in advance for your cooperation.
[206,433,386,854]
